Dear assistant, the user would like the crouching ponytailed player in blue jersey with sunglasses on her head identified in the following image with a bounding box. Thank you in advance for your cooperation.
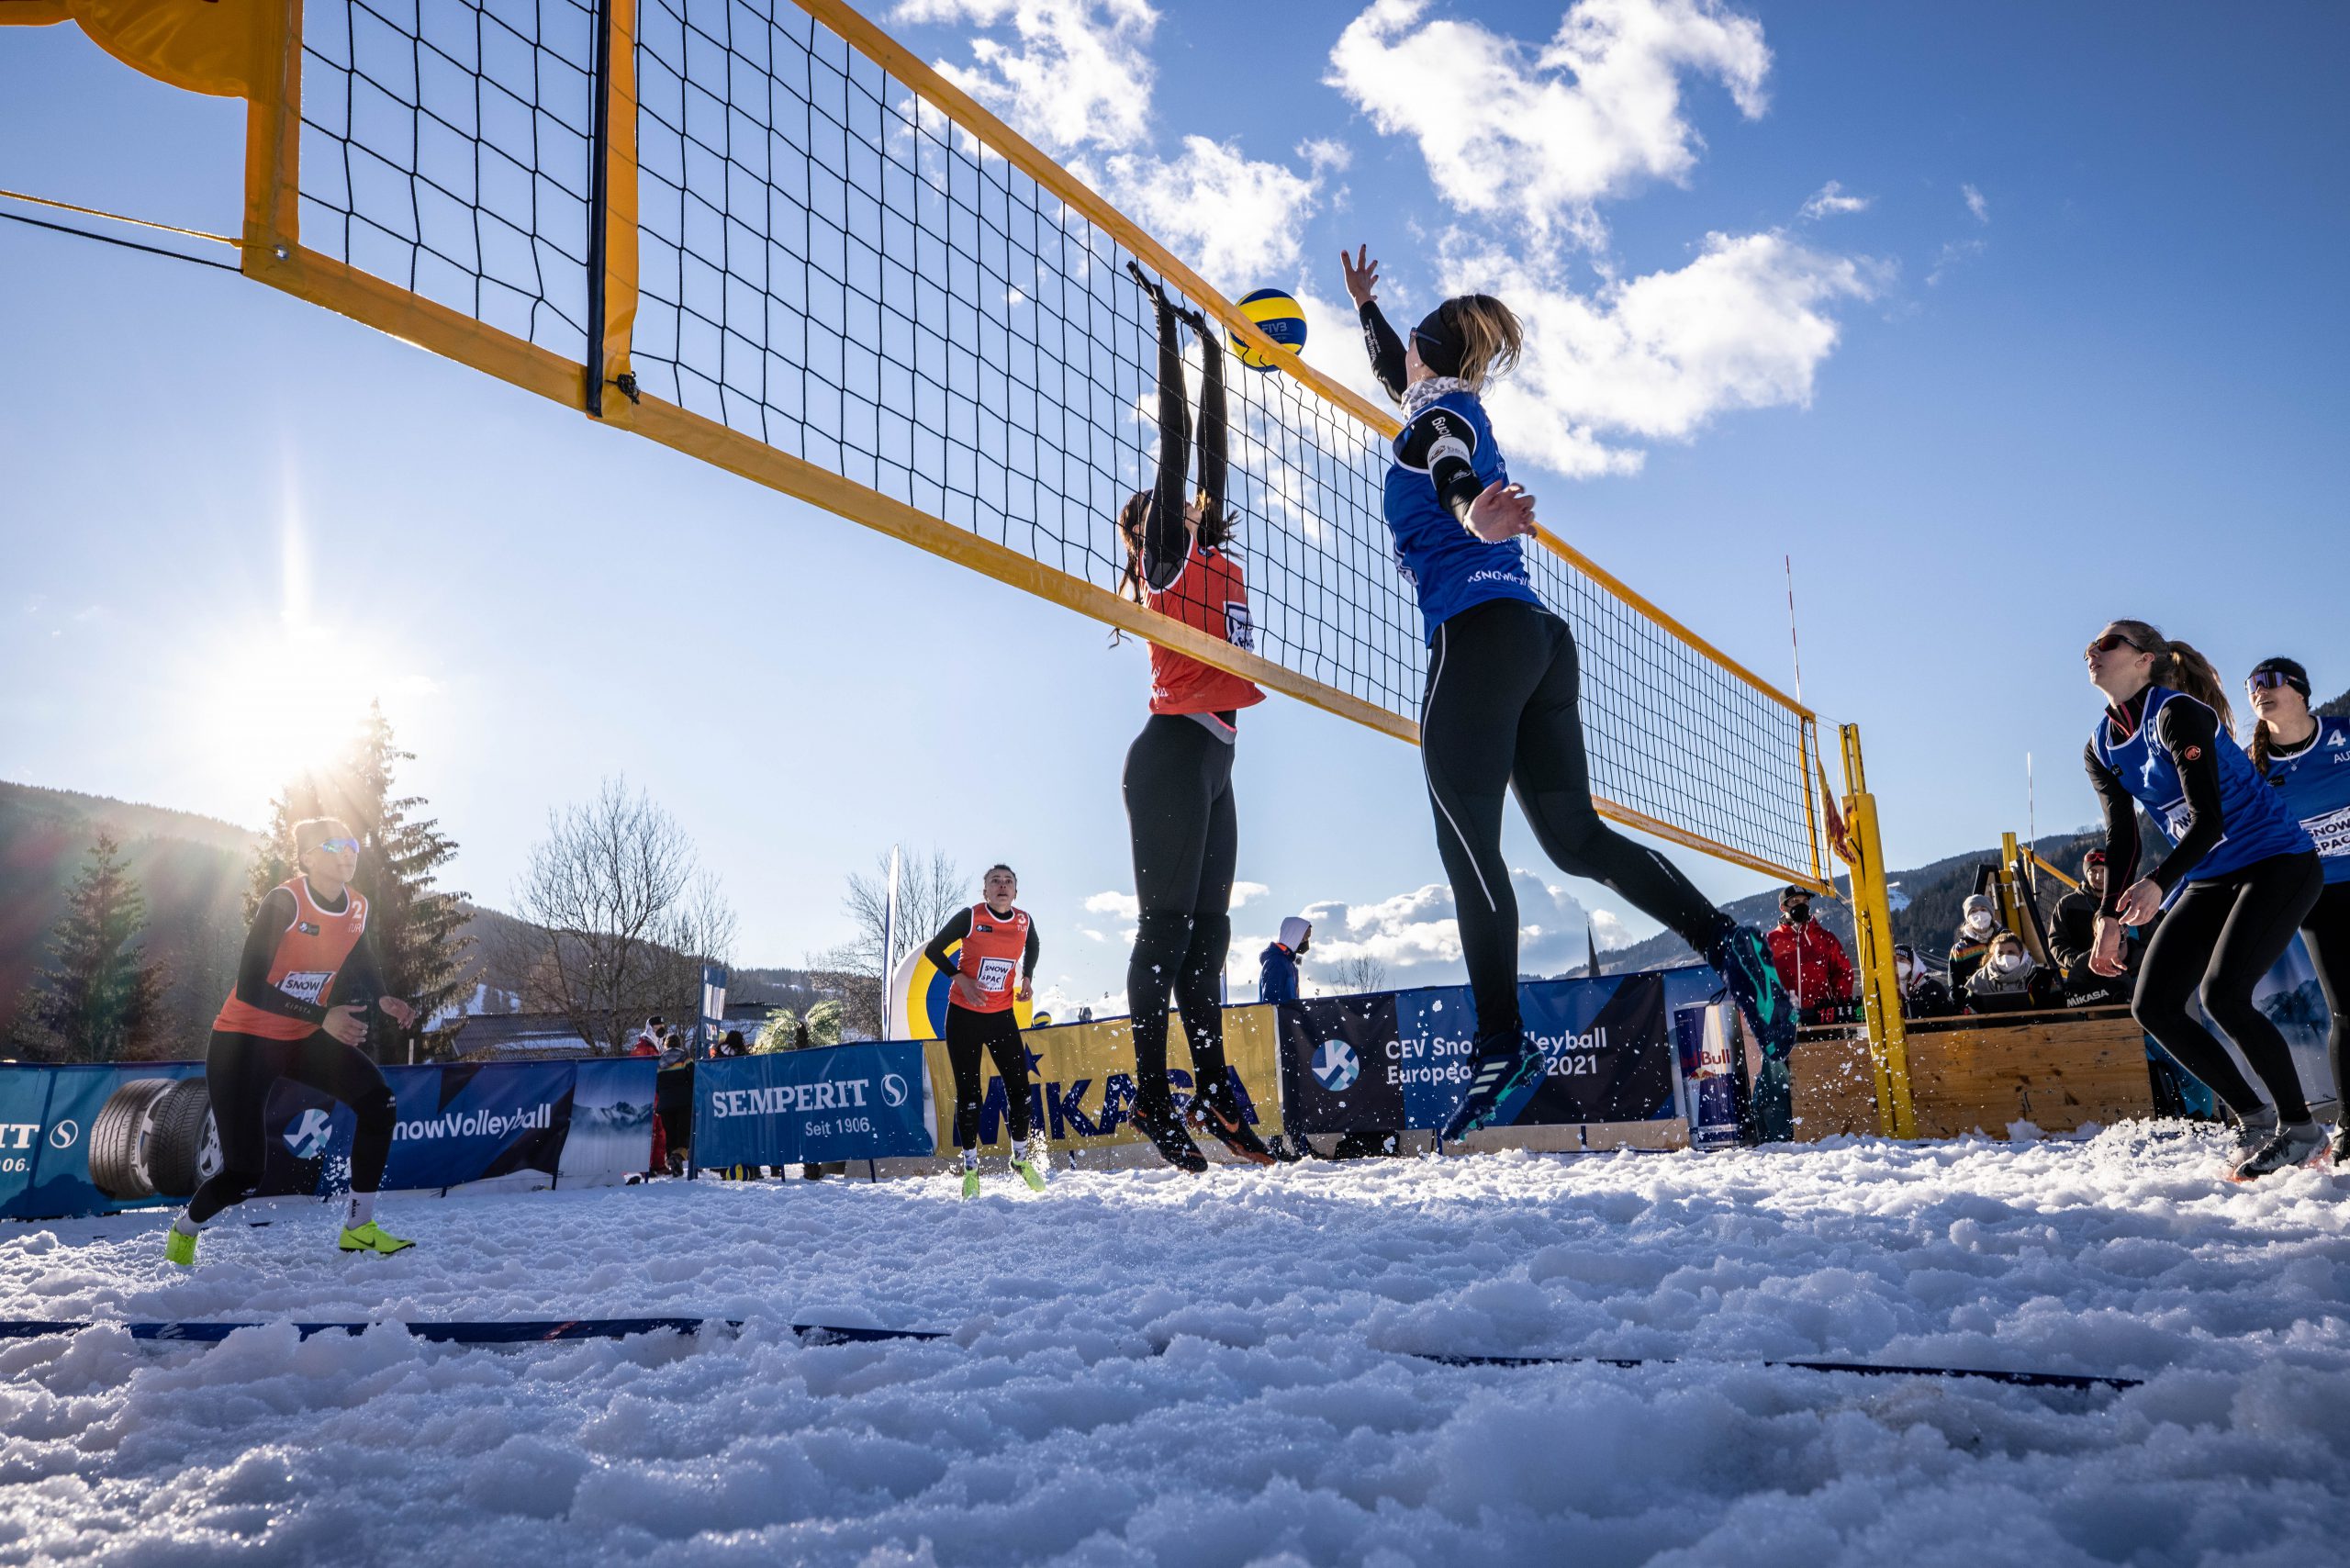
[2082,621,2324,1180]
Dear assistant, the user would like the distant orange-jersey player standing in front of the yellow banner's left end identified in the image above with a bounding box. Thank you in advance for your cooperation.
[923,863,1050,1199]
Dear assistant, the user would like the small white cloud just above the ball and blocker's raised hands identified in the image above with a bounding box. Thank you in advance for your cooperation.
[1107,137,1318,294]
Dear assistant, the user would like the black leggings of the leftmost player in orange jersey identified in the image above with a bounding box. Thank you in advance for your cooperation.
[188,1030,397,1225]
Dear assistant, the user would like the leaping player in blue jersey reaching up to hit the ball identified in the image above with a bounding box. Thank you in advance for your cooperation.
[1339,249,1796,1137]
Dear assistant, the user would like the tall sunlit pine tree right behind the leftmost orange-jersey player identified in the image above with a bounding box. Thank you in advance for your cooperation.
[244,703,473,1058]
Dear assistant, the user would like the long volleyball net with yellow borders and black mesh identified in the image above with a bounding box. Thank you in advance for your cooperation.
[22,0,1824,884]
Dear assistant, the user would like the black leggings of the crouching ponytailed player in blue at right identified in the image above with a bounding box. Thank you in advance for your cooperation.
[2129,851,2324,1121]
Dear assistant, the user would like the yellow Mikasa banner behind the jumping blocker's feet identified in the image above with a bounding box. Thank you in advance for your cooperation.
[923,1006,1283,1152]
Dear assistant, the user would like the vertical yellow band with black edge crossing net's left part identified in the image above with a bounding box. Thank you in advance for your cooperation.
[585,0,637,425]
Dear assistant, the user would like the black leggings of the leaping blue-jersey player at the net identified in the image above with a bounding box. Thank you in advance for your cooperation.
[1419,599,1722,1036]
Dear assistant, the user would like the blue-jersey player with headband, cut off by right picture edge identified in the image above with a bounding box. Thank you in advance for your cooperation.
[2244,658,2350,1166]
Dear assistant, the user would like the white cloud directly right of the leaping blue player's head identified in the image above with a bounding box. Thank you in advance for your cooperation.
[1443,233,1880,477]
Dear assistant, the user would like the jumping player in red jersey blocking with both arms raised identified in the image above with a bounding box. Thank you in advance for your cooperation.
[1119,263,1271,1170]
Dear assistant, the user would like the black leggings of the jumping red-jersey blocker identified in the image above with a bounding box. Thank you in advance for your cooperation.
[1125,712,1241,1105]
